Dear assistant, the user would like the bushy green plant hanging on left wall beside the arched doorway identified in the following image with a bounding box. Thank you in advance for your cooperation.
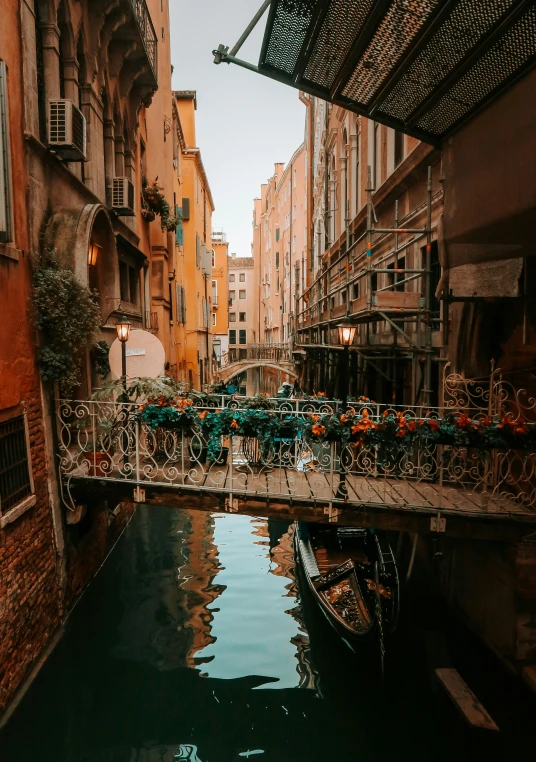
[32,243,100,393]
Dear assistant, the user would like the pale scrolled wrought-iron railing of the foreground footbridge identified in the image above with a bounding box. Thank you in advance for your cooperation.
[58,396,536,517]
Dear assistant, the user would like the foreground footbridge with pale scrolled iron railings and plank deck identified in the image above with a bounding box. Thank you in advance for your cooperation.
[58,370,536,541]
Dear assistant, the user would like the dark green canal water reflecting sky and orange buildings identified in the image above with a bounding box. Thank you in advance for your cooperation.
[0,507,532,762]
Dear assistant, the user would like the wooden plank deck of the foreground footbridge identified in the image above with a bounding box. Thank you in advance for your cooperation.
[64,464,536,542]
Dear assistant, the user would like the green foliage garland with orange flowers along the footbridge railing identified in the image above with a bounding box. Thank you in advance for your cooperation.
[140,399,536,465]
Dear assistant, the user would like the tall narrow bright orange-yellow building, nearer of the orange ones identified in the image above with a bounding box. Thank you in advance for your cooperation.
[174,90,214,389]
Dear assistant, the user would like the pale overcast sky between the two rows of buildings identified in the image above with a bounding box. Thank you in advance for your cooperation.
[170,0,305,256]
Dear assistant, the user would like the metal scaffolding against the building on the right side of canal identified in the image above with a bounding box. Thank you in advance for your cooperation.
[297,167,442,405]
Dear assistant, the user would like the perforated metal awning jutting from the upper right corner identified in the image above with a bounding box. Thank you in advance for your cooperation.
[214,0,536,144]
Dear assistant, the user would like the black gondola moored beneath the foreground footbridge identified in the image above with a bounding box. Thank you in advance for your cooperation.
[294,522,400,661]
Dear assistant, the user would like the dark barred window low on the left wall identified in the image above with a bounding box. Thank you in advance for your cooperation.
[0,415,33,513]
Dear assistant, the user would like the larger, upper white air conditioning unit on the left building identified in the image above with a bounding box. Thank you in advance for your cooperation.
[47,98,86,161]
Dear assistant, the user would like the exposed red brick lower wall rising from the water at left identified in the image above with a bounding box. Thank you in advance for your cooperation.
[0,492,135,726]
